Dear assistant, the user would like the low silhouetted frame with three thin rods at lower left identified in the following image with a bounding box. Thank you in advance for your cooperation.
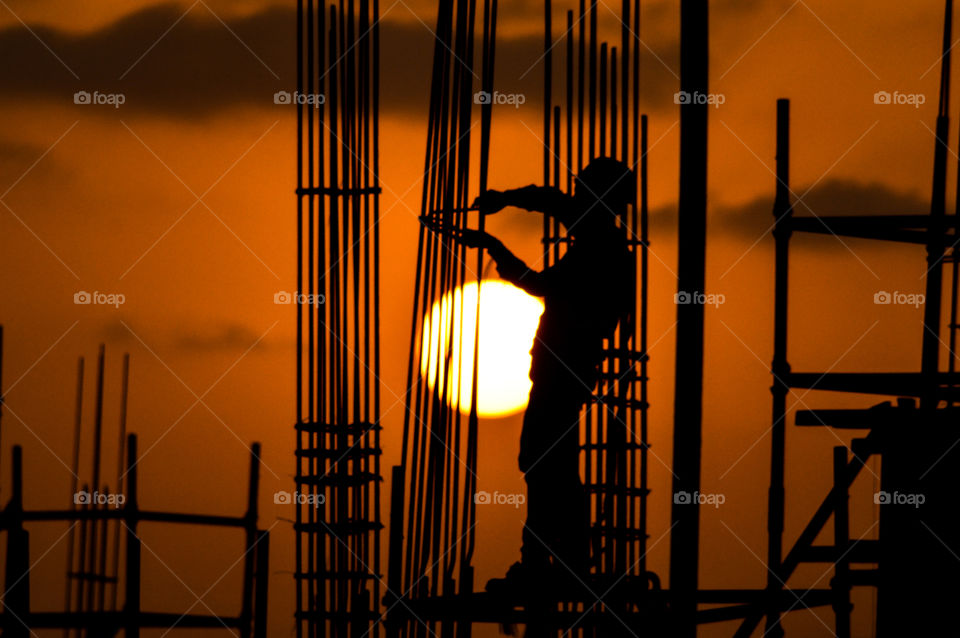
[0,346,270,638]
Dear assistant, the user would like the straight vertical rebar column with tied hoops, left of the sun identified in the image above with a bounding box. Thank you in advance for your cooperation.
[292,0,382,638]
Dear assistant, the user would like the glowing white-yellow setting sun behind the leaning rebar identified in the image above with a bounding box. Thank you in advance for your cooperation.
[420,280,543,417]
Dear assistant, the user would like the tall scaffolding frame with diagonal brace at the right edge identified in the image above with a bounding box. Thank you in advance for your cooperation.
[734,6,960,638]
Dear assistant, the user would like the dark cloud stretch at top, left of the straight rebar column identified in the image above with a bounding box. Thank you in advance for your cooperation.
[0,5,295,114]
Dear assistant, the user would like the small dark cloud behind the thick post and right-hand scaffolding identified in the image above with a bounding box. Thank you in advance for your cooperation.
[650,180,930,246]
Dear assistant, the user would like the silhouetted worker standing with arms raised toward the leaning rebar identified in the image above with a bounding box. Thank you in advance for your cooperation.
[461,158,636,595]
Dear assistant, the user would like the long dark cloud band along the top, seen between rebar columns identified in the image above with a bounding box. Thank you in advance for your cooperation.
[0,4,677,117]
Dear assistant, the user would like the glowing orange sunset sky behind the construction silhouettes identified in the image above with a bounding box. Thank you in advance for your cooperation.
[0,0,958,636]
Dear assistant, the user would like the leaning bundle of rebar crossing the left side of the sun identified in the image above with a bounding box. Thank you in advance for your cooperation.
[384,0,497,636]
